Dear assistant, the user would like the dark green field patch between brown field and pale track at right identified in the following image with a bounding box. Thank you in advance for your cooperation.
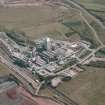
[63,18,100,48]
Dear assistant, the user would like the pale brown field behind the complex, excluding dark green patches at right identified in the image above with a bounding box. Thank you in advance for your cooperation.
[0,5,75,39]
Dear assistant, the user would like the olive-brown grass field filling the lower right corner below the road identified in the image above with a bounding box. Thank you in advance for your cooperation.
[40,67,105,105]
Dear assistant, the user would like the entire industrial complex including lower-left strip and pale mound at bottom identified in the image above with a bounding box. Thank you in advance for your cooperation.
[0,32,90,94]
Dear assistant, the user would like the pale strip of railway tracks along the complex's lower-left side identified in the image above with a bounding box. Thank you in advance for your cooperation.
[0,48,40,94]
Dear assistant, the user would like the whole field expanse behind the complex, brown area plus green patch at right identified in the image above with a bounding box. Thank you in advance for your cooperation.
[0,5,101,48]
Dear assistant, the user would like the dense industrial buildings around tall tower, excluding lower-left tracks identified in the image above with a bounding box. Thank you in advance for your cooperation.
[0,33,90,86]
